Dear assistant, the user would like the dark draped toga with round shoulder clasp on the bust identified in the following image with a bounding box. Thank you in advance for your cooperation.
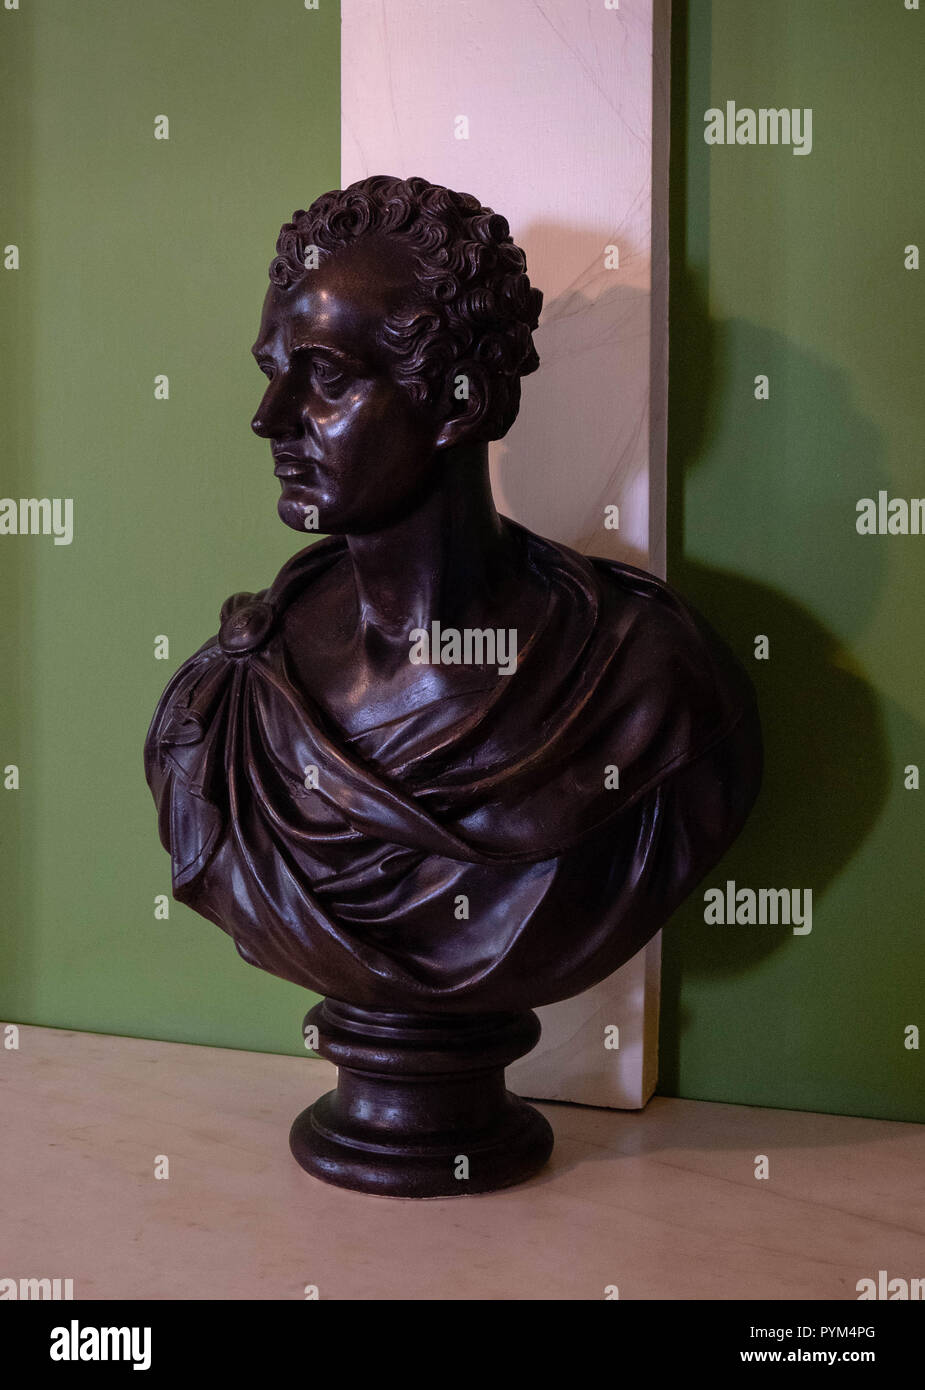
[145,521,761,1012]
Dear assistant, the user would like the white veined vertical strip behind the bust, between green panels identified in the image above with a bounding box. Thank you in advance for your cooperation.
[341,0,670,1109]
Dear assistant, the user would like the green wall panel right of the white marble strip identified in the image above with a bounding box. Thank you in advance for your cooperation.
[659,0,925,1120]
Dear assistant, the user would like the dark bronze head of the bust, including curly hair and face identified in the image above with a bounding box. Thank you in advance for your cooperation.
[252,175,542,535]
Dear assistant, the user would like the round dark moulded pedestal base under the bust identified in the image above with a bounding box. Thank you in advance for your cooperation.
[289,999,552,1197]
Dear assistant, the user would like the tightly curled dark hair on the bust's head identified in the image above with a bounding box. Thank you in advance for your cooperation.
[270,174,542,441]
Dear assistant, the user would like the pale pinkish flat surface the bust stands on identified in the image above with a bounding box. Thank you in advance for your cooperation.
[0,1027,925,1301]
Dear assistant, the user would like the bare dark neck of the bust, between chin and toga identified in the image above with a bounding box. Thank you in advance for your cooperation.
[346,445,513,644]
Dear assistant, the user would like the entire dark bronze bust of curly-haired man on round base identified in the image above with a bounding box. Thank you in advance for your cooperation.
[145,177,761,1195]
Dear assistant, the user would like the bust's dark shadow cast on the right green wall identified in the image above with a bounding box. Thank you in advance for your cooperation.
[658,262,892,1094]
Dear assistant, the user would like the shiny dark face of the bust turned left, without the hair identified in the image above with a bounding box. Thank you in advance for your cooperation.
[244,236,441,535]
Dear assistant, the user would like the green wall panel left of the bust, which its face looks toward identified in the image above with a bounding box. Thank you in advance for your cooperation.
[0,0,339,1051]
